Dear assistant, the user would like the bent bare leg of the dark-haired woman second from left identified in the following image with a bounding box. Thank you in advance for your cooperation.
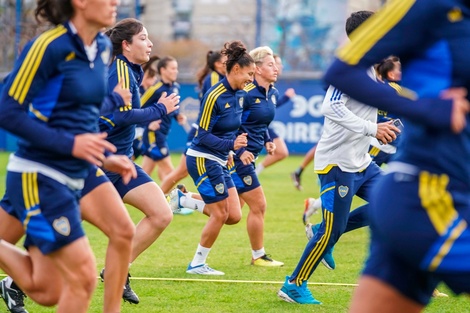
[123,182,173,262]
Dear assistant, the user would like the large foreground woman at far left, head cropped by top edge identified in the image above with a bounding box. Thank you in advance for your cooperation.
[0,0,133,312]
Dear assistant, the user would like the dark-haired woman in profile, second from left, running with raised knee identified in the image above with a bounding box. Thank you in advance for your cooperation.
[100,18,179,303]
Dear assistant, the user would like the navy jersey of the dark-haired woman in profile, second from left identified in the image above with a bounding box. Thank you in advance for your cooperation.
[99,54,166,157]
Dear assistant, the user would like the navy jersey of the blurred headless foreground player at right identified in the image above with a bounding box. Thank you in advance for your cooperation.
[325,0,470,187]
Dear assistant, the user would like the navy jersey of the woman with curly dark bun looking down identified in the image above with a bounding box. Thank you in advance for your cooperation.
[188,78,246,161]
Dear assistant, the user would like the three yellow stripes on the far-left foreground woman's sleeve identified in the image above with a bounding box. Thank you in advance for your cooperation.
[8,25,67,104]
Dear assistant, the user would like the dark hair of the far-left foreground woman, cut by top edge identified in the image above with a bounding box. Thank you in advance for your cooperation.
[34,0,75,25]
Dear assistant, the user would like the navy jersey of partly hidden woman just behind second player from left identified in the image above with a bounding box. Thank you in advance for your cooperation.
[140,81,180,135]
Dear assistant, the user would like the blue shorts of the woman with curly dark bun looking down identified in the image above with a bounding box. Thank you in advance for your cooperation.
[186,155,235,203]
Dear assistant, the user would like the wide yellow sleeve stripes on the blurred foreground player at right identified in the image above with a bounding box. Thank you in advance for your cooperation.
[337,0,416,65]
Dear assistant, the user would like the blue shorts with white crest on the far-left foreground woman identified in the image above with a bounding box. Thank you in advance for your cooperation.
[5,172,85,254]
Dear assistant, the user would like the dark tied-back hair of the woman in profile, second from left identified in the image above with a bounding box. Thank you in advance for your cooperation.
[106,18,144,56]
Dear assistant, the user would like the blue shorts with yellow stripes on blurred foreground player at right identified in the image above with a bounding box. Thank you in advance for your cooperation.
[364,169,470,305]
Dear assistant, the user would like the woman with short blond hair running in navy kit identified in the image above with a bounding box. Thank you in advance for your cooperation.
[231,47,284,266]
